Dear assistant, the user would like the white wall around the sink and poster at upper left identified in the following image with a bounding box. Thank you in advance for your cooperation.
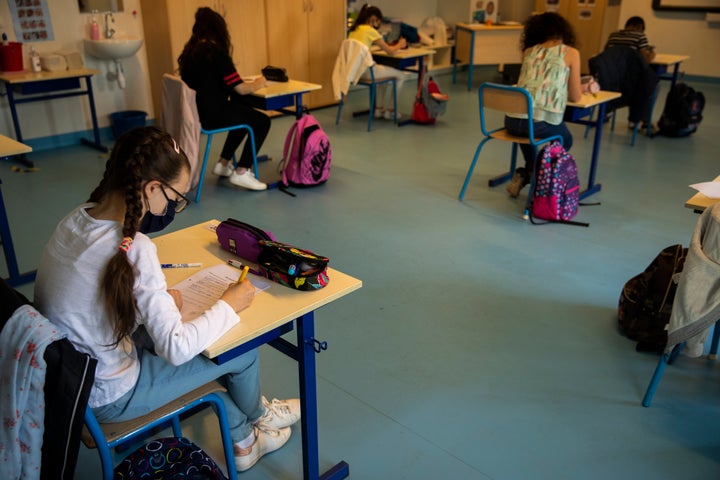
[0,0,153,139]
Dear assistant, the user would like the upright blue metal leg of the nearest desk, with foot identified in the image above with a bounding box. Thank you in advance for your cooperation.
[297,312,350,480]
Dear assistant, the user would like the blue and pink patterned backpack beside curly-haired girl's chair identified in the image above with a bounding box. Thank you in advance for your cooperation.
[530,140,589,227]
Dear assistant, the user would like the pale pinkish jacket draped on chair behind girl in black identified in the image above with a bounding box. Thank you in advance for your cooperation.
[162,73,201,188]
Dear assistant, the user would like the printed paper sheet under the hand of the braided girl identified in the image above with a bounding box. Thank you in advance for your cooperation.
[171,263,270,320]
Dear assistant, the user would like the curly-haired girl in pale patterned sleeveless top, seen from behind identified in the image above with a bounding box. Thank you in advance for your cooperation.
[505,12,582,197]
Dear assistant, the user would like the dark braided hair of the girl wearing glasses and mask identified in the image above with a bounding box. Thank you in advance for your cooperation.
[88,127,190,346]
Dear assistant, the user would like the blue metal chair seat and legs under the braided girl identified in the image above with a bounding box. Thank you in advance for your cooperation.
[82,381,237,480]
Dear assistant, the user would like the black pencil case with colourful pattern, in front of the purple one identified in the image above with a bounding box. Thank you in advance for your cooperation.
[257,240,330,290]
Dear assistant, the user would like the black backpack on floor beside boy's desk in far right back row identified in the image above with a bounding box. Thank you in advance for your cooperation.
[658,83,705,137]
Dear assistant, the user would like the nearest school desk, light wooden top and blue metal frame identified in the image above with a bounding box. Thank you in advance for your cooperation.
[153,220,362,480]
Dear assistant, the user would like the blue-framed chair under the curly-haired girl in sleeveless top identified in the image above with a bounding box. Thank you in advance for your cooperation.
[458,82,563,219]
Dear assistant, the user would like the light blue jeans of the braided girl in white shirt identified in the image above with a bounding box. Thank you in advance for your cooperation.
[93,348,265,442]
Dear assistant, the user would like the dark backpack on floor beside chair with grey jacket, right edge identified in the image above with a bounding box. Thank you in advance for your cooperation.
[618,244,687,353]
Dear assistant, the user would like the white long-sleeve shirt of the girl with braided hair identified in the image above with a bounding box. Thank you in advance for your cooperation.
[35,204,240,407]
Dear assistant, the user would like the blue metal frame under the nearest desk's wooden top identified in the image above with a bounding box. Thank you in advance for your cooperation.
[213,312,350,480]
